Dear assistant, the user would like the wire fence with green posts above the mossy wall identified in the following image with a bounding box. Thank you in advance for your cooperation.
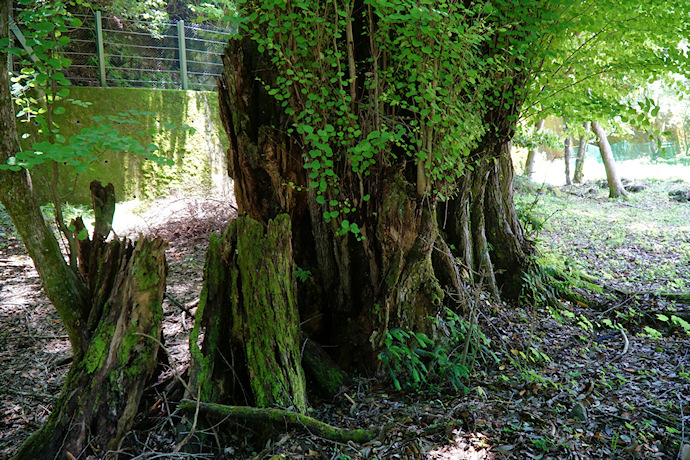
[13,12,232,90]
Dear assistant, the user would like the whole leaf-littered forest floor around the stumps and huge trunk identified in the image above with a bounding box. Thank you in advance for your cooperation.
[0,181,690,460]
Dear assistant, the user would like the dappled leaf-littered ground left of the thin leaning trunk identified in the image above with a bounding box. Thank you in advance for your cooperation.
[0,241,72,458]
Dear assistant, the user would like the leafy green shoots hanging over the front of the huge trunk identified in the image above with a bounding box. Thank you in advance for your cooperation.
[238,0,506,234]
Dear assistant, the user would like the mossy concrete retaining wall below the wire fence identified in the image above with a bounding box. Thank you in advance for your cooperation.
[18,87,230,204]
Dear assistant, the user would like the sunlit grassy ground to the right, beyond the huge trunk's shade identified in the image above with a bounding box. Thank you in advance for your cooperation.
[517,179,690,293]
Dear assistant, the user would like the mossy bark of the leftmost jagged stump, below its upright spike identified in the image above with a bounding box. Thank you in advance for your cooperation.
[14,239,166,460]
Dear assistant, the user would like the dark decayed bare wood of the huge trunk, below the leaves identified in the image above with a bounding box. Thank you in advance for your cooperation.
[210,39,443,374]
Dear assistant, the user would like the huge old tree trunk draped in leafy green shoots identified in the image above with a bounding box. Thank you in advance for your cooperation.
[199,0,542,401]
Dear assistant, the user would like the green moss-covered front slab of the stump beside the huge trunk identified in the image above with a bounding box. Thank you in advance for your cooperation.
[237,214,306,412]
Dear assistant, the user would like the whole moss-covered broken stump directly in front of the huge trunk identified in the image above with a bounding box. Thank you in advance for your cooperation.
[189,214,306,413]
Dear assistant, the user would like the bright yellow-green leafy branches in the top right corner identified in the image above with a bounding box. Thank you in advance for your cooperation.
[526,0,690,128]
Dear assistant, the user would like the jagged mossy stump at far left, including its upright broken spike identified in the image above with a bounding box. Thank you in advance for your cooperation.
[15,181,166,460]
